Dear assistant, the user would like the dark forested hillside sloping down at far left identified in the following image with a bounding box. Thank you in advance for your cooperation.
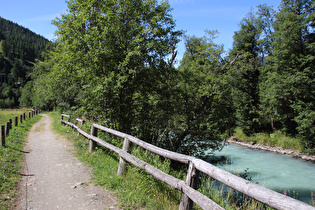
[0,17,51,108]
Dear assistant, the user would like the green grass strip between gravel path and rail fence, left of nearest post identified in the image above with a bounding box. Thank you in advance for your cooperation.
[49,112,186,209]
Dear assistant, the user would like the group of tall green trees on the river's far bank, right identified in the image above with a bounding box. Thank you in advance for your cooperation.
[225,0,315,150]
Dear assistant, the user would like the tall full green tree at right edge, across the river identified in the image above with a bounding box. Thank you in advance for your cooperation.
[261,0,315,144]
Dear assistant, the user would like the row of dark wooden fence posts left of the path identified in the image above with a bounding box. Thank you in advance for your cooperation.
[0,109,39,147]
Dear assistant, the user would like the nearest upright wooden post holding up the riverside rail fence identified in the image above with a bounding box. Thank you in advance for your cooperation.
[179,162,199,210]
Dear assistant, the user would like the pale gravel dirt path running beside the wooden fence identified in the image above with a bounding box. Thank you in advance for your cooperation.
[16,115,119,210]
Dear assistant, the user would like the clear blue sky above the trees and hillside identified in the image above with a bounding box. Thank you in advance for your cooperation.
[0,0,281,59]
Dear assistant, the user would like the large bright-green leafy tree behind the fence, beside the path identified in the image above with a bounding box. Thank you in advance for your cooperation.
[53,0,181,141]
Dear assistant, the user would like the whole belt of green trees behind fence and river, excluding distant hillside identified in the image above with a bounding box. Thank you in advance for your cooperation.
[4,0,315,157]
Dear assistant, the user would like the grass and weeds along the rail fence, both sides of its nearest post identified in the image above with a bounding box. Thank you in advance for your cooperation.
[49,112,271,210]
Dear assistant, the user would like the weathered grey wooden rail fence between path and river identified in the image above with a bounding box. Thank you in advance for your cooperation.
[61,114,315,210]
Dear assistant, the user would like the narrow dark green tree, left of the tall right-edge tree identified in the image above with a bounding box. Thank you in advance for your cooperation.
[228,11,262,135]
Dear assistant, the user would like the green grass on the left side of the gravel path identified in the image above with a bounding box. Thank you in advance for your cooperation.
[0,111,41,210]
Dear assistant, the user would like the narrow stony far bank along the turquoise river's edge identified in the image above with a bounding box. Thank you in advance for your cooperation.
[227,137,315,162]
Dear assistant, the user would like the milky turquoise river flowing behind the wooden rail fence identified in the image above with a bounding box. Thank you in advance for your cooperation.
[208,144,315,203]
